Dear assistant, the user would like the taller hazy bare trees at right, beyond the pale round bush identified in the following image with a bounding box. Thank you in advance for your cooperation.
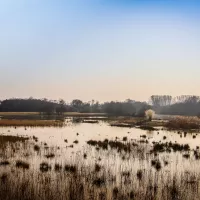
[149,95,200,116]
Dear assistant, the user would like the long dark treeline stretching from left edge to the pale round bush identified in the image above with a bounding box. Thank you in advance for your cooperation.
[0,98,151,116]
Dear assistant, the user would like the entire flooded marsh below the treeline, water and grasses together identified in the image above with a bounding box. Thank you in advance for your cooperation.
[0,96,200,200]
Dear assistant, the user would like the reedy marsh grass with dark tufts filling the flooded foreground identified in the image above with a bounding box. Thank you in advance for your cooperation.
[0,129,200,200]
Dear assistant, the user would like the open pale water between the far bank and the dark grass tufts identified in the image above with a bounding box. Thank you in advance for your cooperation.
[1,120,200,148]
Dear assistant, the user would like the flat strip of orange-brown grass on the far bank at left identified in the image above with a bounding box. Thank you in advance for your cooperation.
[0,119,64,126]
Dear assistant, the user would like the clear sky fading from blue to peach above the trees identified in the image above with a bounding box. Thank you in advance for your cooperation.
[0,0,200,102]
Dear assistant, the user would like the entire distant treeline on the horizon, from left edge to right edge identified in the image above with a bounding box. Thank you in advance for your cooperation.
[0,95,200,117]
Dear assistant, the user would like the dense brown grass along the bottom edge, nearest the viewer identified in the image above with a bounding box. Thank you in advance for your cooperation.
[0,166,200,200]
